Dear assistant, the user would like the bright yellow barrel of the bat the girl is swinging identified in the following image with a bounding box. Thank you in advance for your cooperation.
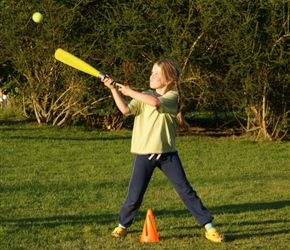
[54,48,116,86]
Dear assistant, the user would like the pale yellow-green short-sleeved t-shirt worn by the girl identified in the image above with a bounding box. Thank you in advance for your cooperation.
[128,90,178,154]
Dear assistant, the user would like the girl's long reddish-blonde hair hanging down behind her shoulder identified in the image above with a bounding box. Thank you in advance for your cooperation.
[155,59,189,131]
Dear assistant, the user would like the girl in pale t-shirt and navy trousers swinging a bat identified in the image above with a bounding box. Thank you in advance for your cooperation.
[102,59,224,242]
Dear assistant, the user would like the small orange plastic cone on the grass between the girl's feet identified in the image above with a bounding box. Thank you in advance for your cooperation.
[140,209,159,242]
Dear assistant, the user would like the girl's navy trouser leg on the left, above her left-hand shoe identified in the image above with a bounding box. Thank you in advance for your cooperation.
[118,155,155,228]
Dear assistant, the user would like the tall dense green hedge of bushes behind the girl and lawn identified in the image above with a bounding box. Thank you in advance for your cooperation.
[0,0,290,140]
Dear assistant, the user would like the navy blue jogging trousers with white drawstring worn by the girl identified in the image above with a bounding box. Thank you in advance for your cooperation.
[118,153,213,228]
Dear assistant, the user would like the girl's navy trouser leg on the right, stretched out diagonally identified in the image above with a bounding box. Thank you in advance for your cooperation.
[158,153,213,226]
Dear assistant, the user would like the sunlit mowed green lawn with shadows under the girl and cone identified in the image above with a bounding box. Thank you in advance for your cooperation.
[0,123,290,250]
